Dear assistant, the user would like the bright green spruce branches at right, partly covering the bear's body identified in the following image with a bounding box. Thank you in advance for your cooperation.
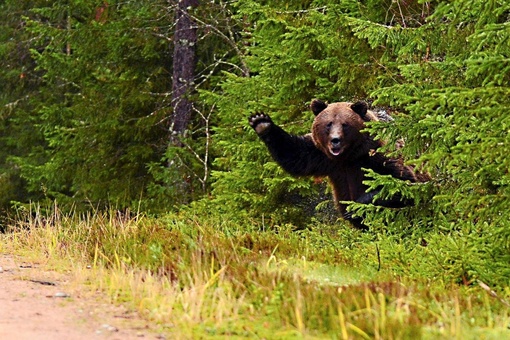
[351,1,510,283]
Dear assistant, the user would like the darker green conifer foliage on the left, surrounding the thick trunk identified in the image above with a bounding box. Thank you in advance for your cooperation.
[0,1,251,212]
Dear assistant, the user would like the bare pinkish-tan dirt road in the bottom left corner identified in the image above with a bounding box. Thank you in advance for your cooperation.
[0,254,157,340]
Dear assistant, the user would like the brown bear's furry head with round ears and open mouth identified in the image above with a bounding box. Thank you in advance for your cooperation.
[310,99,377,159]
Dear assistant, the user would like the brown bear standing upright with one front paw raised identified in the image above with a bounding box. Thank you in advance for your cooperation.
[249,99,428,229]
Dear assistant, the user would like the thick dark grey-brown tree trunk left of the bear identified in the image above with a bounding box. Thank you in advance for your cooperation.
[170,0,199,139]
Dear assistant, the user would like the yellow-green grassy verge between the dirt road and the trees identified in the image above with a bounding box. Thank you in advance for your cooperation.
[0,206,510,339]
